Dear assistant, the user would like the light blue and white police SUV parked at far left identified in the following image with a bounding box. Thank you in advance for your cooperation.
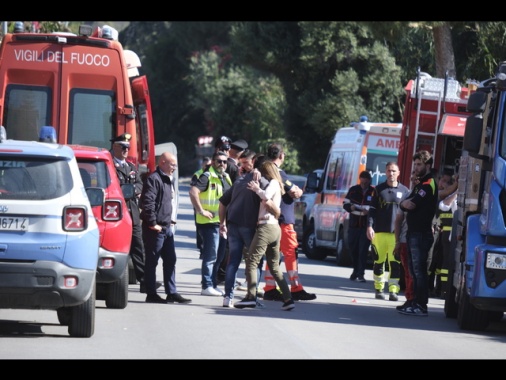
[0,127,103,337]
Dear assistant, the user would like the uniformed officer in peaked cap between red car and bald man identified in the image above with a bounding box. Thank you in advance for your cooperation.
[110,133,161,293]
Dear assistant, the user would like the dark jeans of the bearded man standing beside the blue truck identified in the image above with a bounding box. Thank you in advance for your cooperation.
[406,230,434,308]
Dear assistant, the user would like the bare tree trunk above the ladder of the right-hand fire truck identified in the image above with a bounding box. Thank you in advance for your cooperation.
[432,22,457,78]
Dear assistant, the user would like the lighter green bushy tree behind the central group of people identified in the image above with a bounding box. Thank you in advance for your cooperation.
[186,46,299,172]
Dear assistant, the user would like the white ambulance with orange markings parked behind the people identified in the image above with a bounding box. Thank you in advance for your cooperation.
[302,116,402,266]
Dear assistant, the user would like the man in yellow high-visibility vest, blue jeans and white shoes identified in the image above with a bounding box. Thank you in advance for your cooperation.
[190,151,232,297]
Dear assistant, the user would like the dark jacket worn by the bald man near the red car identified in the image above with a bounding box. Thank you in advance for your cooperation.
[141,167,175,227]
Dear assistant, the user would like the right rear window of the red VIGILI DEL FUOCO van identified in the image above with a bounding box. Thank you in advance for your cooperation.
[67,89,116,149]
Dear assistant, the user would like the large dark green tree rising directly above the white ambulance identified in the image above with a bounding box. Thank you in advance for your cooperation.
[231,22,403,171]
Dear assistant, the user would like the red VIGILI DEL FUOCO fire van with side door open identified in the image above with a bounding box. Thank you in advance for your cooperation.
[0,25,156,173]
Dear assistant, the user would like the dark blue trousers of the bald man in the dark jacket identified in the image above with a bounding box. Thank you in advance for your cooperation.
[142,223,177,294]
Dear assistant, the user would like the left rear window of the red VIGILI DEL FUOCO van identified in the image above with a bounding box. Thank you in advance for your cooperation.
[4,84,51,141]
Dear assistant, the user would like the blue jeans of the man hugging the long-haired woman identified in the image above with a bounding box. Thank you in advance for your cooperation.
[225,223,263,299]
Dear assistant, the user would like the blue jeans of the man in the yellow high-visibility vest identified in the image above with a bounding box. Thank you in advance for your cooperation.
[198,223,223,289]
